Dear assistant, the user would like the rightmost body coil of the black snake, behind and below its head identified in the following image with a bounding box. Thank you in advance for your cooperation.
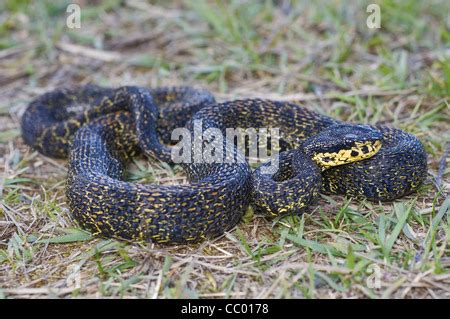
[322,125,427,201]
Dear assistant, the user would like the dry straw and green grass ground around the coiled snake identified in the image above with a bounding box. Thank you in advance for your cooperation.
[0,0,450,298]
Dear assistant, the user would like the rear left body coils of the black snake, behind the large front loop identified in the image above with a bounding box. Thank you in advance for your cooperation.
[21,85,215,158]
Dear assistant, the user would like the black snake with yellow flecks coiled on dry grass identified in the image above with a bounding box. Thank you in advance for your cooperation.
[21,84,427,244]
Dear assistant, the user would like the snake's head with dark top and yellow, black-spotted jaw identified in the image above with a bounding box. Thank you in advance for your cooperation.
[303,124,383,170]
